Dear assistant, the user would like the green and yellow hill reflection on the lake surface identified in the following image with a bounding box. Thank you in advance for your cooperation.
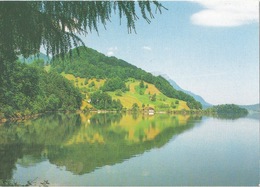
[0,113,201,180]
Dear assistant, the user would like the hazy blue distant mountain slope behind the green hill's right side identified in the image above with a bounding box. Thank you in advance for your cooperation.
[153,72,213,109]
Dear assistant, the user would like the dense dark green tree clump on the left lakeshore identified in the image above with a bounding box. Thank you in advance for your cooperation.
[0,61,82,120]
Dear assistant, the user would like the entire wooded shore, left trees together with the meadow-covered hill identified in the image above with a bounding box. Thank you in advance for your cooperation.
[0,47,201,120]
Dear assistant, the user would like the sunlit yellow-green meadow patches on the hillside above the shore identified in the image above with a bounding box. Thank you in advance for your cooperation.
[61,72,189,111]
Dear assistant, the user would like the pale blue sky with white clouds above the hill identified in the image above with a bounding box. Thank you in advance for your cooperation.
[78,0,259,105]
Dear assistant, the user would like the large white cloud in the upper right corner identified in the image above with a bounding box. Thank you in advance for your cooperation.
[191,0,259,27]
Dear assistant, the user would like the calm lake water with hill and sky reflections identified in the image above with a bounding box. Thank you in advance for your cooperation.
[0,114,259,186]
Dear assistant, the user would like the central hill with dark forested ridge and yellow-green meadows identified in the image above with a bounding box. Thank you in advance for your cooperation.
[51,47,202,110]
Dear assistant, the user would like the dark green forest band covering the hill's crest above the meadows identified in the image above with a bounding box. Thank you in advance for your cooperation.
[51,47,202,109]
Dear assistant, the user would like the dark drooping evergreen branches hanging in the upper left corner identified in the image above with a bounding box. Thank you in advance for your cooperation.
[0,1,163,63]
